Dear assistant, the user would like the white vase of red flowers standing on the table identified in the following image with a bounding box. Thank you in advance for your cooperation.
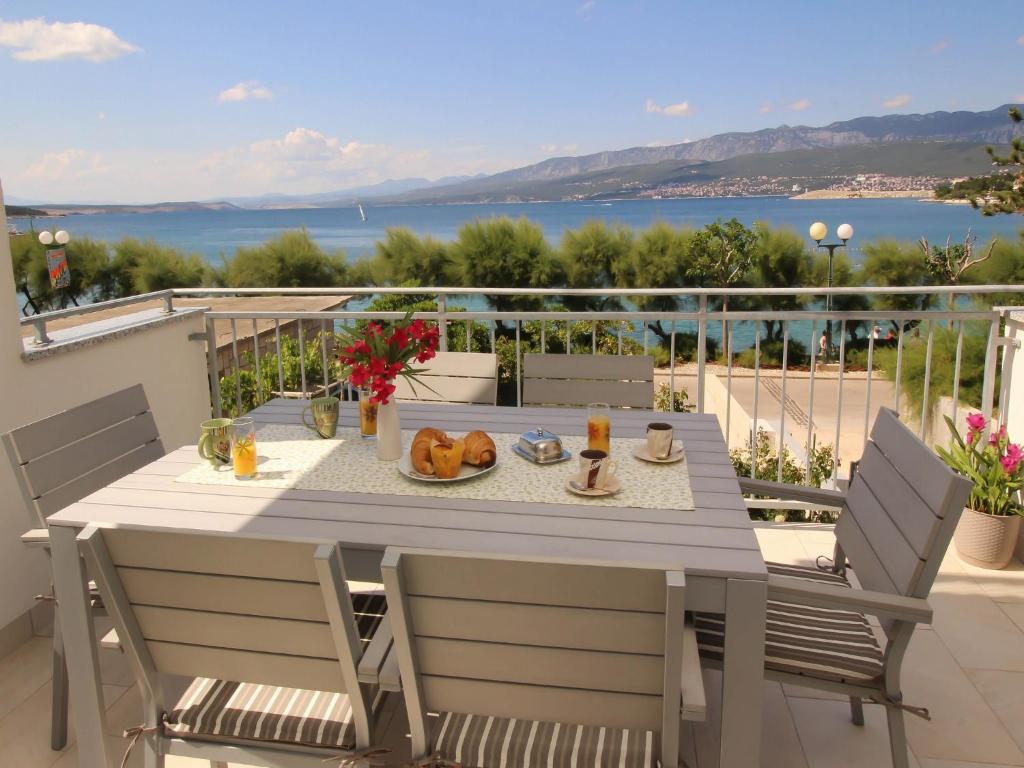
[338,312,440,461]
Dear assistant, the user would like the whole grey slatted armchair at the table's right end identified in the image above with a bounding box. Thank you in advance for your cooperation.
[696,409,971,768]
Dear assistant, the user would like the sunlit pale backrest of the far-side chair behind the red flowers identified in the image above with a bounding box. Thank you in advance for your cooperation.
[395,352,498,406]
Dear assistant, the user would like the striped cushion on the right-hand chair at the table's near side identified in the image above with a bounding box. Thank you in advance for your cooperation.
[430,712,662,768]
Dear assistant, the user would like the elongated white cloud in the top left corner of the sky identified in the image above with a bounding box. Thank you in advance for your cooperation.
[0,18,141,62]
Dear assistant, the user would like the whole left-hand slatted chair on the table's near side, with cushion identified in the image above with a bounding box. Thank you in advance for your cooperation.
[78,526,390,768]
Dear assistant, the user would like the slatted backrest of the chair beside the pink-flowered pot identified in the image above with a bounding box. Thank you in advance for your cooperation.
[836,409,971,597]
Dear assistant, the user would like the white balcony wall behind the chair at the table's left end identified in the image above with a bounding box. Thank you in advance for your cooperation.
[0,182,210,629]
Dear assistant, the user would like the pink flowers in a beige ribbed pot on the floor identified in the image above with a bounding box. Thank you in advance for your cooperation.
[936,414,1024,568]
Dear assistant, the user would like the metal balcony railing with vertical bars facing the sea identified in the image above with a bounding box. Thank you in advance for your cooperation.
[22,286,1024,493]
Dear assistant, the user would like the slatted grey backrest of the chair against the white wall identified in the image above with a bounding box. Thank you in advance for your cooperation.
[2,384,164,527]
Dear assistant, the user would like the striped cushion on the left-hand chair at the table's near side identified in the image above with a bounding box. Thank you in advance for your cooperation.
[164,594,387,750]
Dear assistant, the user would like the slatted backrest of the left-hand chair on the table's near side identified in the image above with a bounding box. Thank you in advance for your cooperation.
[79,526,371,743]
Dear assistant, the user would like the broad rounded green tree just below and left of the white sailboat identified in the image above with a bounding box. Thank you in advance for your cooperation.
[221,229,347,288]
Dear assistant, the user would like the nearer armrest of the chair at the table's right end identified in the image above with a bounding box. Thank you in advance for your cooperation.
[768,574,932,624]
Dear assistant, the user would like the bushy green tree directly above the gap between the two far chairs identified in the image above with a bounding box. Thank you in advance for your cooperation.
[452,216,558,312]
